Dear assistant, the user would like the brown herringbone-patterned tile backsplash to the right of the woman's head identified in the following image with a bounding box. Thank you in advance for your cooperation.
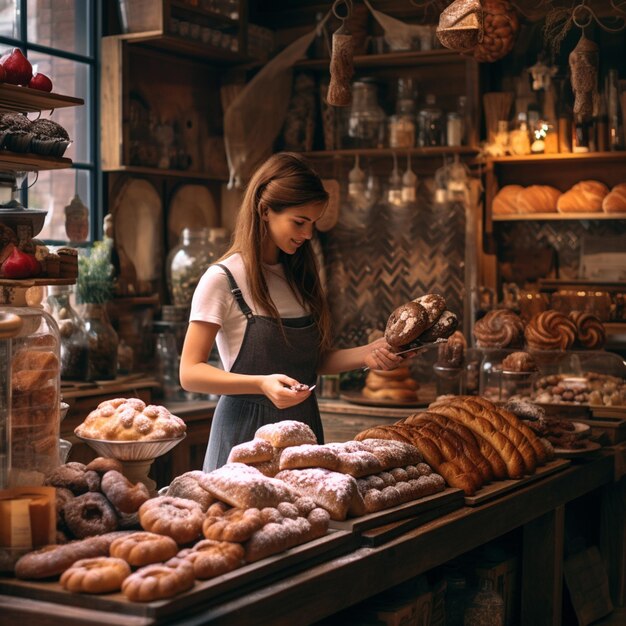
[322,192,465,347]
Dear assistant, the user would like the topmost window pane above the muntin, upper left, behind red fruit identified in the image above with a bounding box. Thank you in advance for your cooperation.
[26,0,92,55]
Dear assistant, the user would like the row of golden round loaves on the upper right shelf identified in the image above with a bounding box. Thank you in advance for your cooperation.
[492,180,626,215]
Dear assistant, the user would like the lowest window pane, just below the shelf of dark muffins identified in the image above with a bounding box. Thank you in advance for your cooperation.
[28,169,94,241]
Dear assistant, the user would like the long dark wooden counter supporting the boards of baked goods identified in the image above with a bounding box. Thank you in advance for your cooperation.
[0,451,624,626]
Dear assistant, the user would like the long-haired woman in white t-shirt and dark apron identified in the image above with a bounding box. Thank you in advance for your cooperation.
[180,153,403,471]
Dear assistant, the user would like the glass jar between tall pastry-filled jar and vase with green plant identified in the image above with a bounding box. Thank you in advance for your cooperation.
[46,285,89,380]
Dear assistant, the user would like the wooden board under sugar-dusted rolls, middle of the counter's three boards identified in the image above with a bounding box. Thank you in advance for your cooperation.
[330,487,463,533]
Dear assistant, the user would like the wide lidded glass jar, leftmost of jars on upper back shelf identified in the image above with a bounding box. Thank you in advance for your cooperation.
[348,79,385,148]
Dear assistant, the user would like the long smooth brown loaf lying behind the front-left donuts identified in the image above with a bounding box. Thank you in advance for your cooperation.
[15,532,127,580]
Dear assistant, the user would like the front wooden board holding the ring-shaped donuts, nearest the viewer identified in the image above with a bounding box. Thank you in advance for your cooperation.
[0,530,358,624]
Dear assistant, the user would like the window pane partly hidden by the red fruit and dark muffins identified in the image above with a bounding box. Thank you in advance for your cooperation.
[28,51,91,163]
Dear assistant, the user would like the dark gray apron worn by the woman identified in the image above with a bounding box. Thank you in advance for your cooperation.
[202,264,324,472]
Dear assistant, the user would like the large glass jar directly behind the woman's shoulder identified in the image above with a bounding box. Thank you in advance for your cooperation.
[166,228,209,308]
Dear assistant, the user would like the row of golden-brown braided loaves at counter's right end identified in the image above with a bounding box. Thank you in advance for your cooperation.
[356,396,553,496]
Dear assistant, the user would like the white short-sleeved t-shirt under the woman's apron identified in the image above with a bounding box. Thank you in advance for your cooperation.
[189,254,308,371]
